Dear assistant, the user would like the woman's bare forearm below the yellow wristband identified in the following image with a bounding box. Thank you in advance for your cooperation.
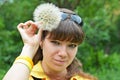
[3,63,30,80]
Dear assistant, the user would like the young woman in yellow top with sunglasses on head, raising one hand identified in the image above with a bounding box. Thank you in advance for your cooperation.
[3,9,96,80]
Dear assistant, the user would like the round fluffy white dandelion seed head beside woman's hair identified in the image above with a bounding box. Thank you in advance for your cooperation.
[33,3,61,31]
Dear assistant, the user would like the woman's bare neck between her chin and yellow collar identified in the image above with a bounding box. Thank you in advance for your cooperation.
[42,62,67,80]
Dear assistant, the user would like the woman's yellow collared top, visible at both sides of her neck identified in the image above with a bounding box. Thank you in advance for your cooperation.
[29,62,89,80]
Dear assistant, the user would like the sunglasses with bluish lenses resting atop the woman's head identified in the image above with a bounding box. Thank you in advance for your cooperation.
[61,12,83,27]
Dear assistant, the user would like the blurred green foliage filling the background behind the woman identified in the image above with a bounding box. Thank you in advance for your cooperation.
[0,0,120,80]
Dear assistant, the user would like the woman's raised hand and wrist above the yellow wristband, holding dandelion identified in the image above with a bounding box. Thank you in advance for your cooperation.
[17,21,42,58]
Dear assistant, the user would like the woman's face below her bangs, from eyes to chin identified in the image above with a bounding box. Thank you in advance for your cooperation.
[42,36,78,72]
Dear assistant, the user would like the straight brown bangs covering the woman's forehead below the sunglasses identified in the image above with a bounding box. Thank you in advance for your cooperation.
[42,20,84,44]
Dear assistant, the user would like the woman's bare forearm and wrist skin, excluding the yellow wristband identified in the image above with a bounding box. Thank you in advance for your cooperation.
[3,45,35,80]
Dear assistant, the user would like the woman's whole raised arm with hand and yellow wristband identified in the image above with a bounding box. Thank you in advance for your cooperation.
[3,21,42,80]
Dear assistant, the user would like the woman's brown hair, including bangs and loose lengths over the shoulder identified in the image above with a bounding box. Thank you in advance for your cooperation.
[33,9,95,80]
